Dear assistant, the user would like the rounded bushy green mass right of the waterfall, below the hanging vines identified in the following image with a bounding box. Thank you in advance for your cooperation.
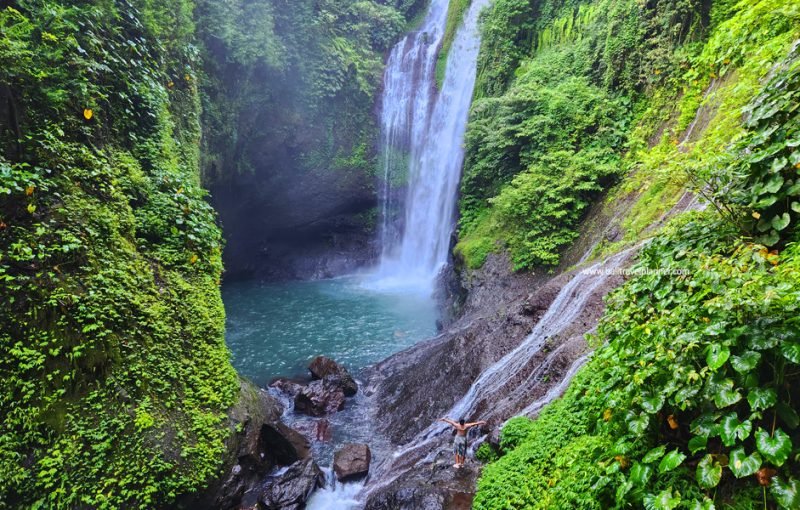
[456,66,625,269]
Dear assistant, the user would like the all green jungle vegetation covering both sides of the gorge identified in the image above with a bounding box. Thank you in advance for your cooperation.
[0,0,800,510]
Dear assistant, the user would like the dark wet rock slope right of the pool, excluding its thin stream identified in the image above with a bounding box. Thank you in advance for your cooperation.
[360,250,622,509]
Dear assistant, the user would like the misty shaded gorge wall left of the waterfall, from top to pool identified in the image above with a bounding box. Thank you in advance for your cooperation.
[197,0,425,279]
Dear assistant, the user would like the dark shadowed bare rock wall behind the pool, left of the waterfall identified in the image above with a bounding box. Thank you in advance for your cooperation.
[211,161,377,280]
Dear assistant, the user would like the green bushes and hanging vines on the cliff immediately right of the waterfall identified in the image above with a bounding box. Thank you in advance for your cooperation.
[459,0,708,269]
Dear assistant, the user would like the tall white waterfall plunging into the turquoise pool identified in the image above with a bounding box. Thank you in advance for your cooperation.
[377,0,490,289]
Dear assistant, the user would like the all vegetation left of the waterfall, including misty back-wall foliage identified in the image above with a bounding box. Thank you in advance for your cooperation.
[0,0,422,508]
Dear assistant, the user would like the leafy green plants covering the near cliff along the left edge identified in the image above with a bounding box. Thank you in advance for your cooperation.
[0,0,238,508]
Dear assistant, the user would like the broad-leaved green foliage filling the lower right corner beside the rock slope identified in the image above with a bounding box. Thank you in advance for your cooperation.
[476,214,800,508]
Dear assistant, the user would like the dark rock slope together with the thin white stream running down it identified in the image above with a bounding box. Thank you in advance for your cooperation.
[365,250,633,510]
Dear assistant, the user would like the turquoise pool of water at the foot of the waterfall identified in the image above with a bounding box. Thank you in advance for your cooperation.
[222,277,437,386]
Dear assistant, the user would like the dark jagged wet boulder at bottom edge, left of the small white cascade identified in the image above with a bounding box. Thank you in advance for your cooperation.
[258,458,325,510]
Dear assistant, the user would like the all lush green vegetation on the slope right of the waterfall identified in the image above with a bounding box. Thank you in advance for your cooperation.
[472,0,800,509]
